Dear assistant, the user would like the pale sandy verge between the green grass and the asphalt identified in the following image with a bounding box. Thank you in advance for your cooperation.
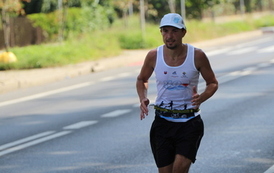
[0,30,262,94]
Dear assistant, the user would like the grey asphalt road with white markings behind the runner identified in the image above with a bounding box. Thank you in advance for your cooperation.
[0,34,274,173]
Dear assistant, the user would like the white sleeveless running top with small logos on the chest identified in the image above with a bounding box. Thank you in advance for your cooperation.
[154,44,200,122]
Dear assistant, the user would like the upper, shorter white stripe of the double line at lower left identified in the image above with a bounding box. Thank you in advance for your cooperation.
[0,131,55,150]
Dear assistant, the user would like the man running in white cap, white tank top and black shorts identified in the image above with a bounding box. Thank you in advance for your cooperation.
[136,13,218,173]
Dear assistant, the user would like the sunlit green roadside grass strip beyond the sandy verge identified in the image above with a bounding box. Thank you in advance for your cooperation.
[0,15,274,70]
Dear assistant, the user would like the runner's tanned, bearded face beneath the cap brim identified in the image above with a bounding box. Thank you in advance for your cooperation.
[161,26,186,49]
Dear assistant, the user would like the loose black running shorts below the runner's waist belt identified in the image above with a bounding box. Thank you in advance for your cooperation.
[150,115,204,168]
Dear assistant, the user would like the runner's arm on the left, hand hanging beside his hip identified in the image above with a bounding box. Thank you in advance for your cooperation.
[136,49,157,120]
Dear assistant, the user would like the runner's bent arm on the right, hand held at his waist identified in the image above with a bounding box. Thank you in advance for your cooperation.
[192,49,218,108]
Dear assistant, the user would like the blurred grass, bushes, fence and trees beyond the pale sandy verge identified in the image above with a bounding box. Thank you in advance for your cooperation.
[0,0,274,70]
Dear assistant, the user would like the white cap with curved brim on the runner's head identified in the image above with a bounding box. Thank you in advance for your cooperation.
[160,13,186,29]
